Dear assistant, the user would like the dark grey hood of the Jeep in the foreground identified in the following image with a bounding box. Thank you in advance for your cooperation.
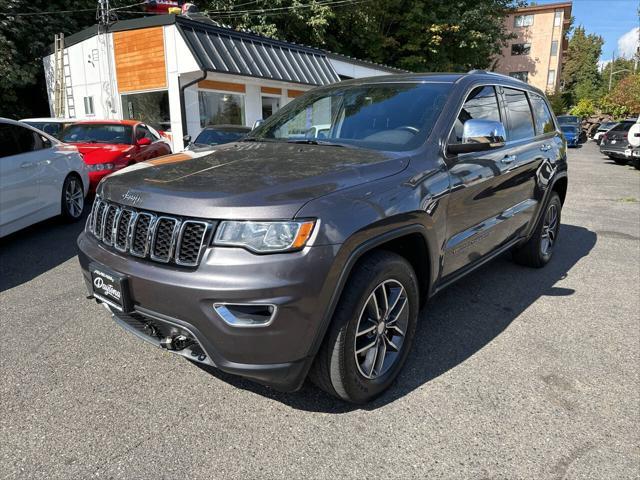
[98,142,409,219]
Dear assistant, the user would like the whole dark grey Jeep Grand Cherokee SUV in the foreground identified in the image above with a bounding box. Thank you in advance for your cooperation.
[78,72,567,402]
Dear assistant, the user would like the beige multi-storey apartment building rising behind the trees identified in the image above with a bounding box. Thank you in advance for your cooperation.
[494,2,571,93]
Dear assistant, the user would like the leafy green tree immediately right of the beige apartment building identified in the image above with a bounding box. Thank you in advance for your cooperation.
[562,26,604,104]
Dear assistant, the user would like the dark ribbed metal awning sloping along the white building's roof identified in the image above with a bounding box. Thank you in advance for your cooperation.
[176,18,340,85]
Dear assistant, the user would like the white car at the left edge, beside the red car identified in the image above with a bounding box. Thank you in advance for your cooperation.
[0,118,89,237]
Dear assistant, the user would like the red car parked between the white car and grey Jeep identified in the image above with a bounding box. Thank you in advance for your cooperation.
[61,120,171,192]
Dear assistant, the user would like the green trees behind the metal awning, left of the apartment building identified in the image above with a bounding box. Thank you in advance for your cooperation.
[206,0,524,71]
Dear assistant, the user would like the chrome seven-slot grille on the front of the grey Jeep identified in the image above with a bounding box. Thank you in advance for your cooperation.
[88,197,215,267]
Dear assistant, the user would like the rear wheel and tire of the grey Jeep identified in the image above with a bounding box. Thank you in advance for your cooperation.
[513,192,562,268]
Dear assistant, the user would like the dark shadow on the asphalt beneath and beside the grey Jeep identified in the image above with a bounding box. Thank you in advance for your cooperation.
[194,225,597,413]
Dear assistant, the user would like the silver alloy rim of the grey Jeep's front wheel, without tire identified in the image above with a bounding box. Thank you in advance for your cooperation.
[354,280,409,380]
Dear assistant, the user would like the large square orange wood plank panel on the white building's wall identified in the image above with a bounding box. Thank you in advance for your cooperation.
[113,27,167,93]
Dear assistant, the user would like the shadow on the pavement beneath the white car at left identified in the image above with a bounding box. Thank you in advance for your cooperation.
[0,207,91,292]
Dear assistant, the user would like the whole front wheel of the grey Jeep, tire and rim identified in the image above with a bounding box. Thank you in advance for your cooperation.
[310,251,419,403]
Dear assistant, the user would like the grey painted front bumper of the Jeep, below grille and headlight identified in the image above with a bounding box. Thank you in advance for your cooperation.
[78,232,339,390]
